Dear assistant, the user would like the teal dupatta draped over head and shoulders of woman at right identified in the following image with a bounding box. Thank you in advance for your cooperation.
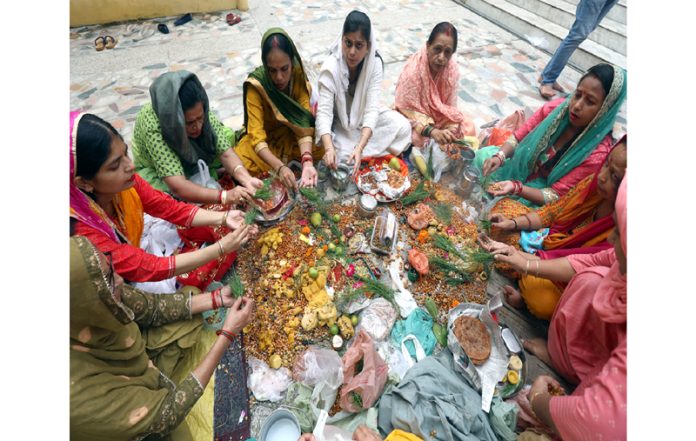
[492,65,627,188]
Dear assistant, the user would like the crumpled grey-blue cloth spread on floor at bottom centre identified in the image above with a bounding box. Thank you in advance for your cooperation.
[378,349,497,441]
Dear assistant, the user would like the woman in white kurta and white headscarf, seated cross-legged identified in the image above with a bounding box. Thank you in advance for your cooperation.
[316,11,411,173]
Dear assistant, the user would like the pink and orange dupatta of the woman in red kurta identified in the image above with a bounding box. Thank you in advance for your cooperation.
[70,111,144,246]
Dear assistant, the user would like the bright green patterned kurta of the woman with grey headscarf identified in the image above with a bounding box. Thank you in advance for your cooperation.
[131,103,236,192]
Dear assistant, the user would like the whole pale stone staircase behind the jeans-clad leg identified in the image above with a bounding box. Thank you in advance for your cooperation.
[455,0,626,72]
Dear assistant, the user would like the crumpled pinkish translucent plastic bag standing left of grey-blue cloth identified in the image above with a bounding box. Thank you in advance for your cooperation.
[340,329,389,412]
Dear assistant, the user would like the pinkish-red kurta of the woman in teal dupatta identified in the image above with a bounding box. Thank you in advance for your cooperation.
[513,98,614,196]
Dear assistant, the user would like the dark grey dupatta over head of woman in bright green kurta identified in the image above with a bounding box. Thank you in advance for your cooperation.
[150,70,217,170]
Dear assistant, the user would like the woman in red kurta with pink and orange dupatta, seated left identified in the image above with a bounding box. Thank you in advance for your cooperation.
[70,112,257,289]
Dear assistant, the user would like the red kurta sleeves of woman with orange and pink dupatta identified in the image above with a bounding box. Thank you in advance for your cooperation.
[75,174,198,282]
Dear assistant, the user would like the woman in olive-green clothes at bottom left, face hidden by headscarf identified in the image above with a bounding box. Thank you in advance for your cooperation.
[70,236,253,441]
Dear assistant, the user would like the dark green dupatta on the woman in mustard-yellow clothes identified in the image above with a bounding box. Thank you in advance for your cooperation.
[242,28,314,136]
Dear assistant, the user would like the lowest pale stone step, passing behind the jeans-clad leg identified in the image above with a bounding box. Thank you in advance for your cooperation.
[455,0,626,72]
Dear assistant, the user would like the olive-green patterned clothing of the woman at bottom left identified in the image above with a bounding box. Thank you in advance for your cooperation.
[70,236,203,440]
